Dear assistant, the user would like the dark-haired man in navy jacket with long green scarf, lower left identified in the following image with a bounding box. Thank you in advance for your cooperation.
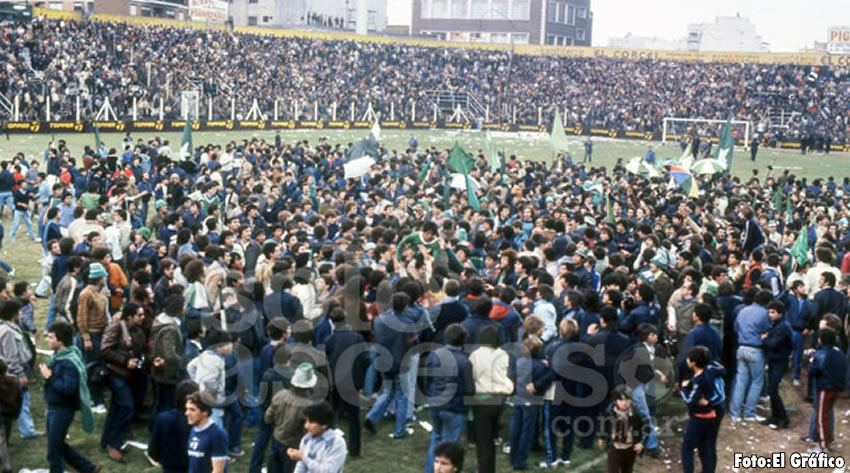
[39,321,101,473]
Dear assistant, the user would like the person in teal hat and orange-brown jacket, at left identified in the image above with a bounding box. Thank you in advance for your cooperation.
[77,263,109,414]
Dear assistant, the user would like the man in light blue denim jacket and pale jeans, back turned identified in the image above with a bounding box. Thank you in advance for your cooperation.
[729,290,773,422]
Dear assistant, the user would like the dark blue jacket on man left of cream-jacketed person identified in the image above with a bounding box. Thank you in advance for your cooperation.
[426,345,475,414]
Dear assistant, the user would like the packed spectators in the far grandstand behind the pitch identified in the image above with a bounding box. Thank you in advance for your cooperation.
[0,19,850,145]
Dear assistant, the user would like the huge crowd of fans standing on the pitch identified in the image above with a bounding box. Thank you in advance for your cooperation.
[0,124,850,473]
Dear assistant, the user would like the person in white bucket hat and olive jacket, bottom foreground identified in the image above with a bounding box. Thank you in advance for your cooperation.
[265,362,318,473]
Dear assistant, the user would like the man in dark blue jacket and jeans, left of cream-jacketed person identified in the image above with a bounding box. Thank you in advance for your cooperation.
[425,324,475,473]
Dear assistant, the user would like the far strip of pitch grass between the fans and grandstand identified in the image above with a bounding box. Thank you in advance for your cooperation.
[0,129,850,182]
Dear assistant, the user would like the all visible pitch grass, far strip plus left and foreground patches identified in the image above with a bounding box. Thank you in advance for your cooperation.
[0,126,850,473]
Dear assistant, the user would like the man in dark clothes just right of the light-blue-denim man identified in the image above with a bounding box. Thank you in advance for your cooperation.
[761,301,792,429]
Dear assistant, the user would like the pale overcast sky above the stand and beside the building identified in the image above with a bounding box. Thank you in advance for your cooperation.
[387,0,850,52]
